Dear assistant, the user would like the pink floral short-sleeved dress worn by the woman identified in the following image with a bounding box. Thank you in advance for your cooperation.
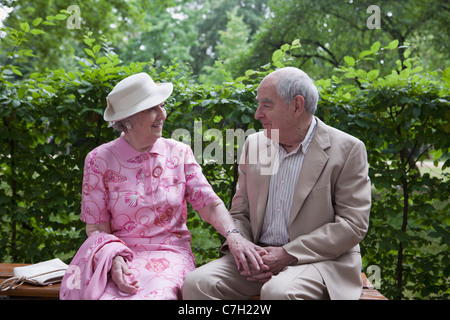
[81,134,219,299]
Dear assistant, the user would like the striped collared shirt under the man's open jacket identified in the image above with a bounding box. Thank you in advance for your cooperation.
[259,117,317,246]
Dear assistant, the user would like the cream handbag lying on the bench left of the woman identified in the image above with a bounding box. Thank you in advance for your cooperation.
[0,258,68,291]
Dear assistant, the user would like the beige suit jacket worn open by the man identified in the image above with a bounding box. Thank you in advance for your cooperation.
[230,119,371,299]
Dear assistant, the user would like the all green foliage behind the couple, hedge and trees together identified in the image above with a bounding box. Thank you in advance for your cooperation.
[0,0,450,299]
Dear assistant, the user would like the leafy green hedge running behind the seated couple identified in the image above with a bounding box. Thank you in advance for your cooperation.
[0,14,450,298]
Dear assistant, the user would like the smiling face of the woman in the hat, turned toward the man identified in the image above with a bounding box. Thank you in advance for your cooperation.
[126,102,167,151]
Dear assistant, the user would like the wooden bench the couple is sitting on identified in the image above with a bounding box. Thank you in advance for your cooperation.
[0,263,387,300]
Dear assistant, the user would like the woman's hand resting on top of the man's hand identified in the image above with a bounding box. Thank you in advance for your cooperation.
[227,233,266,272]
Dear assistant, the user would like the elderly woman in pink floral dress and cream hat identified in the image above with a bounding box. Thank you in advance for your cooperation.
[60,73,262,299]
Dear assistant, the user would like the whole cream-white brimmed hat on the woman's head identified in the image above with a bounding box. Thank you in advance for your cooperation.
[103,72,173,121]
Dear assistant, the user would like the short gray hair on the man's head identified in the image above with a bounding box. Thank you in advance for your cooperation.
[272,67,319,115]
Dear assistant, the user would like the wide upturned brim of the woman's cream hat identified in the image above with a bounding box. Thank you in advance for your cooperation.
[103,83,173,121]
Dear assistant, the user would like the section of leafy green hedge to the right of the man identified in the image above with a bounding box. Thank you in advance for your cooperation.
[319,41,450,298]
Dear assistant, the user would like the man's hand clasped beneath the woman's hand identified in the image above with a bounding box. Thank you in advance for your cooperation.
[241,247,297,283]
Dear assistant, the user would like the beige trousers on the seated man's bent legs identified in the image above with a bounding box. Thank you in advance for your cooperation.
[182,254,329,300]
